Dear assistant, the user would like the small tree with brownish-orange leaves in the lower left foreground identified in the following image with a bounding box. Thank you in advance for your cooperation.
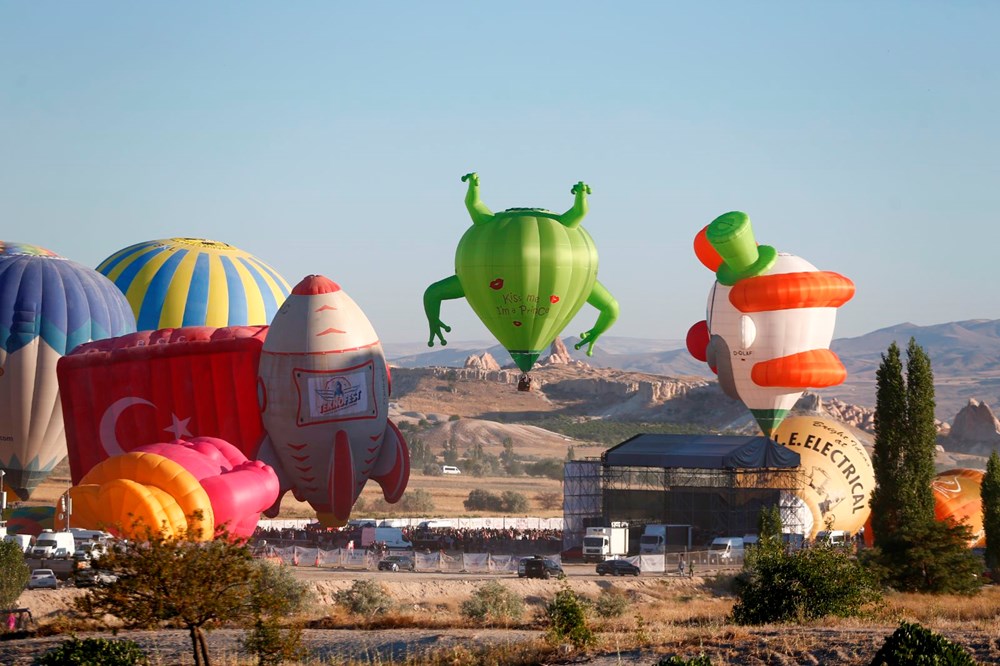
[75,514,304,666]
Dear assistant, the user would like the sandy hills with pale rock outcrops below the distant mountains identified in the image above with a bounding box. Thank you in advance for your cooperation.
[392,338,1000,469]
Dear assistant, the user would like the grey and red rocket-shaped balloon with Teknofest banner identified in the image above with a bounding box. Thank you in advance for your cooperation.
[258,275,410,527]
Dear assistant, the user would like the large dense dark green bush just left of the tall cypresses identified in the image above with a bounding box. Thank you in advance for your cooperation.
[733,546,880,624]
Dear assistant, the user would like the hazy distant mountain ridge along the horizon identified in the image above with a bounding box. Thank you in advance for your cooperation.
[387,319,1000,422]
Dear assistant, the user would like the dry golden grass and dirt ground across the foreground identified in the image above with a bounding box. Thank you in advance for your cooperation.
[0,567,1000,666]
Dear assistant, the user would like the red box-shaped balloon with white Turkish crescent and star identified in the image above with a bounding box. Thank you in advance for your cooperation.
[56,326,267,484]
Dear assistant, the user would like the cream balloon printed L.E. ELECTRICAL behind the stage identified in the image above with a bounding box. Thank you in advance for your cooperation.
[773,416,875,539]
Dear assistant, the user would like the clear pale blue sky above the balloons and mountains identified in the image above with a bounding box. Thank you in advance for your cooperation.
[0,0,1000,346]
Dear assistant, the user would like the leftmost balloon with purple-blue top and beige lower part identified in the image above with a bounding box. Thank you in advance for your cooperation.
[0,242,135,499]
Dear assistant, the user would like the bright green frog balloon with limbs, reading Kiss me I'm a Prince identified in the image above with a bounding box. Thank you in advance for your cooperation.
[424,173,618,373]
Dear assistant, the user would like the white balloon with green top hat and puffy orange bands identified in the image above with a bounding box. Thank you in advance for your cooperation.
[687,212,854,437]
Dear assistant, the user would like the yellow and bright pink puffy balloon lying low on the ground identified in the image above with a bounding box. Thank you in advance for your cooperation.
[69,437,278,539]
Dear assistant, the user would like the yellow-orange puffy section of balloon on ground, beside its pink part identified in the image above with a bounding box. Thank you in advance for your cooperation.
[69,452,215,540]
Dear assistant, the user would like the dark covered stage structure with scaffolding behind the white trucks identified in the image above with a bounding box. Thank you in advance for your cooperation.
[563,434,812,548]
